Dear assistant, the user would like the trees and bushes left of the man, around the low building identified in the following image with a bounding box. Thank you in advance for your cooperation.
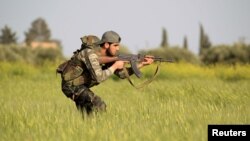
[0,18,65,65]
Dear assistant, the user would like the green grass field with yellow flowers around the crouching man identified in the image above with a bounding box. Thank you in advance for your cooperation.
[0,62,250,141]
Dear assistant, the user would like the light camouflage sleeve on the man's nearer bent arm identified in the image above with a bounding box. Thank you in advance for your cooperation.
[79,49,113,83]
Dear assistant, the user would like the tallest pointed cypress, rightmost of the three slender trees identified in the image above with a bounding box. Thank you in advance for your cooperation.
[199,24,211,56]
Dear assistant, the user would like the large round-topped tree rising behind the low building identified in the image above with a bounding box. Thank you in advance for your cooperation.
[25,18,51,45]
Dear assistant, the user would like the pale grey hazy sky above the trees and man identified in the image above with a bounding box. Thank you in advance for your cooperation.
[0,0,250,56]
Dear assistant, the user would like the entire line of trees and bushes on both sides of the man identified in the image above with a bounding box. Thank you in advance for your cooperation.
[0,18,250,64]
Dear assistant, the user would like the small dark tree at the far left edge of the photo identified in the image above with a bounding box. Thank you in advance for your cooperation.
[0,25,17,44]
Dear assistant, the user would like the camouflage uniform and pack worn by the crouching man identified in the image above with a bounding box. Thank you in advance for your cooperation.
[57,35,133,114]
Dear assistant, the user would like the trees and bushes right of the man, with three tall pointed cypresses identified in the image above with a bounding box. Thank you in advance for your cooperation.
[139,24,250,65]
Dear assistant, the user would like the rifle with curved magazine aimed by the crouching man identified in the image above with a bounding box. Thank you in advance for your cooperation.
[99,54,174,78]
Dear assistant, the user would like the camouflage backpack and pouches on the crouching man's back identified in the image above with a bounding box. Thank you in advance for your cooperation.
[56,35,100,86]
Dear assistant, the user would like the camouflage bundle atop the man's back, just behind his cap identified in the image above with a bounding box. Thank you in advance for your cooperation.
[80,35,100,47]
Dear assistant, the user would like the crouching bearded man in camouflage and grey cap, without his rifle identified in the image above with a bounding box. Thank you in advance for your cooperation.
[57,31,153,114]
